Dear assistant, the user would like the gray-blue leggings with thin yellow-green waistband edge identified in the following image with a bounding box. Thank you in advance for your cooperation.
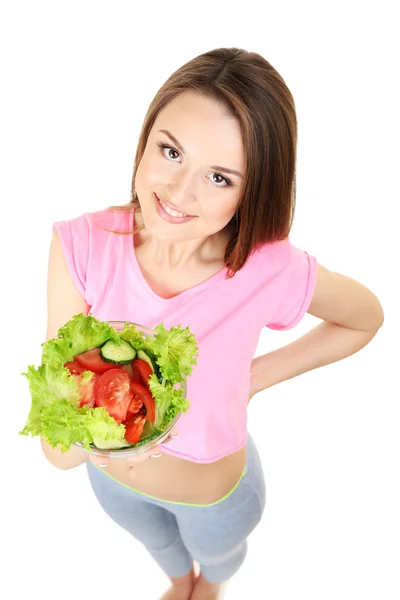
[86,434,265,583]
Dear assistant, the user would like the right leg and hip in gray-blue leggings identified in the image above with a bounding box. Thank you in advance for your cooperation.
[173,436,265,586]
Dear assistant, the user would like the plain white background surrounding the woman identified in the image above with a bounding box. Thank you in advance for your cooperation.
[0,0,400,600]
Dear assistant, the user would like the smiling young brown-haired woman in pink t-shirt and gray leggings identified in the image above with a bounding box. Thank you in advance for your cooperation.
[42,48,383,600]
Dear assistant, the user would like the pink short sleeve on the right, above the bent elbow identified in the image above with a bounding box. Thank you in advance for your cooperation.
[267,242,318,331]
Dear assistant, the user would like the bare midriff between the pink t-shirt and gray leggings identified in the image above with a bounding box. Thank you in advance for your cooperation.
[104,446,246,504]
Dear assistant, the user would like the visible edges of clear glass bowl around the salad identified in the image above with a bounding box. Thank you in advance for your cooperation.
[75,321,187,458]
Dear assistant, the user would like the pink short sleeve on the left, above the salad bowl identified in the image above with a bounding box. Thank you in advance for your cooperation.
[52,215,90,301]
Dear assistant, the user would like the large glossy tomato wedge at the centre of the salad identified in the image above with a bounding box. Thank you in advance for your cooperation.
[94,369,132,423]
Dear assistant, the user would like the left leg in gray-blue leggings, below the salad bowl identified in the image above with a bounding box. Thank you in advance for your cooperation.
[87,461,193,583]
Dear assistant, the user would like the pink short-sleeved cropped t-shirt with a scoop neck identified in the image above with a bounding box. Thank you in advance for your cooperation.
[53,209,317,463]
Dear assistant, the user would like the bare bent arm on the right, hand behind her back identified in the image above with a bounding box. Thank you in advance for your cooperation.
[249,265,384,399]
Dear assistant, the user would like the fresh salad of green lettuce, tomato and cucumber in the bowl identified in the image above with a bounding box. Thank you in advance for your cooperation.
[19,313,198,452]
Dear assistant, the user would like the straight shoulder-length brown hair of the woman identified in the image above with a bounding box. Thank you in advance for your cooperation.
[111,48,297,277]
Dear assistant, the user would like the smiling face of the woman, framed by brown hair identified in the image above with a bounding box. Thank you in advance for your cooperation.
[135,91,244,241]
